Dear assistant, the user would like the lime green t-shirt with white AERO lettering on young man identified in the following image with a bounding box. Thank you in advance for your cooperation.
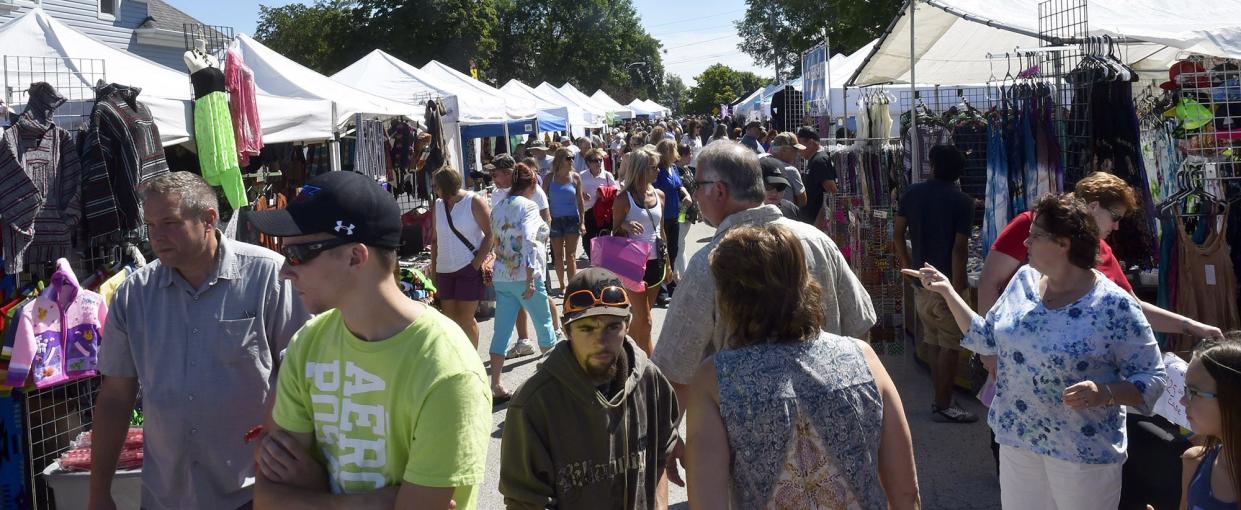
[272,308,491,510]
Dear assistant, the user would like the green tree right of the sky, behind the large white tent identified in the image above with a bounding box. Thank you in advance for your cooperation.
[736,0,903,77]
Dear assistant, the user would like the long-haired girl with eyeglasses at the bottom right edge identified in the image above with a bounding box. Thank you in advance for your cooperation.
[1180,331,1241,510]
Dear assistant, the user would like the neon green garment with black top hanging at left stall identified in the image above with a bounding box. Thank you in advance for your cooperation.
[190,67,246,210]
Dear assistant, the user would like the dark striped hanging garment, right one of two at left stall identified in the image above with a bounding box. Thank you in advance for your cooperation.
[82,83,168,242]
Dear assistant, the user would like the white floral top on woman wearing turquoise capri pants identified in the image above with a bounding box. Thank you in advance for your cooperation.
[491,196,550,282]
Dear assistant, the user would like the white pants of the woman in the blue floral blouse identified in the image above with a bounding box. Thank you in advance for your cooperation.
[1000,444,1124,510]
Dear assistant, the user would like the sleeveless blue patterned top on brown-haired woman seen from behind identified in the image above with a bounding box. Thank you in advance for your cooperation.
[715,333,887,509]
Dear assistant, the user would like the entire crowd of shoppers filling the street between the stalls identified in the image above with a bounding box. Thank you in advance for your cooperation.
[82,111,1241,509]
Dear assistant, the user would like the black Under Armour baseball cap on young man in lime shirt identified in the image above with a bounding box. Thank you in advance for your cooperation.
[241,171,401,249]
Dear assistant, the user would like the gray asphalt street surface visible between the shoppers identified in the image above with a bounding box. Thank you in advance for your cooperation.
[466,223,1000,510]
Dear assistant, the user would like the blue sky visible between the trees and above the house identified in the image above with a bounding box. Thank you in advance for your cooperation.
[169,0,773,86]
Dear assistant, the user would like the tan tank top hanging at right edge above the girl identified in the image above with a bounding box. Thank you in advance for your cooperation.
[1174,211,1241,350]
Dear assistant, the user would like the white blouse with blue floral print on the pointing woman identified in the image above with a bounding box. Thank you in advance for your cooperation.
[961,266,1168,464]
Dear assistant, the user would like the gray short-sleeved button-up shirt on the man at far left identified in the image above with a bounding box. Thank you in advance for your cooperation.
[99,235,309,509]
